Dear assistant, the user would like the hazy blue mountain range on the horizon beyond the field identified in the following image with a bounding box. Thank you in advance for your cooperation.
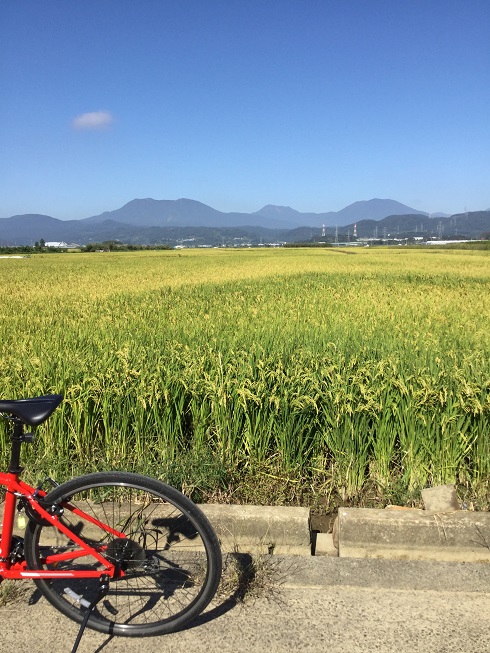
[0,199,490,245]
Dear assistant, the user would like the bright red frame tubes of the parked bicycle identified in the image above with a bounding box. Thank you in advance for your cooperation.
[0,472,126,580]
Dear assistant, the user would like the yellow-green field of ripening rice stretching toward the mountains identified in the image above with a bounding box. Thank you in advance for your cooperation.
[0,248,490,507]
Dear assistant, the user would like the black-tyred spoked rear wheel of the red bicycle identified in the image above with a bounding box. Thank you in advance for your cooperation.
[24,472,221,637]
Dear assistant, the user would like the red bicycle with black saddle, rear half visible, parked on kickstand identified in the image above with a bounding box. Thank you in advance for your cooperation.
[0,395,221,651]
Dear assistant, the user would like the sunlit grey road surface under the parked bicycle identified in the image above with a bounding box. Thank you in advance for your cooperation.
[0,557,490,653]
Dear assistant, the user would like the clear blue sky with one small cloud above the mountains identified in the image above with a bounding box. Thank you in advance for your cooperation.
[0,0,490,219]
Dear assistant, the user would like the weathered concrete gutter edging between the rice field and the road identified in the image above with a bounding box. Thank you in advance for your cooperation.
[0,494,490,562]
